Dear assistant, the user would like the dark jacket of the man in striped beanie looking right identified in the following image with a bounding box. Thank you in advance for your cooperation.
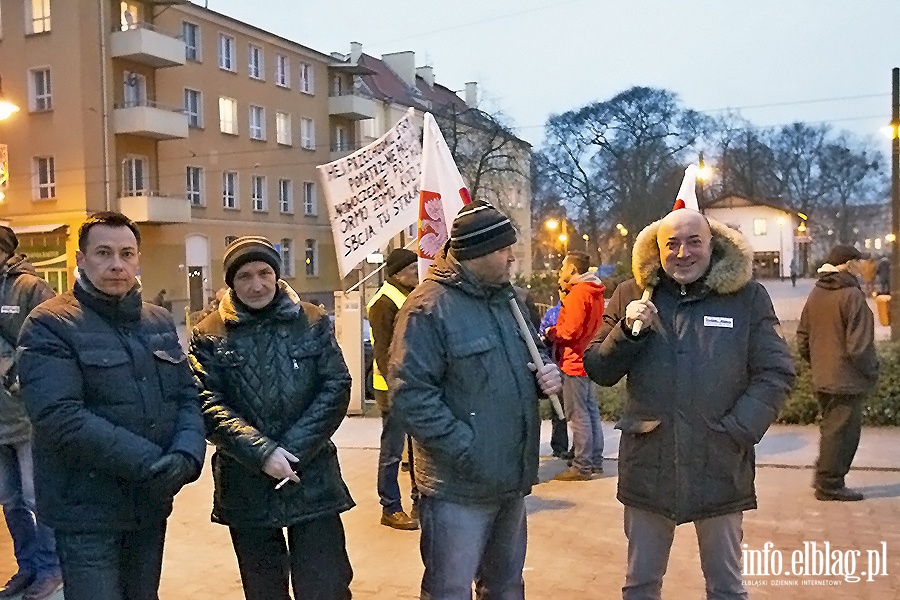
[388,251,548,503]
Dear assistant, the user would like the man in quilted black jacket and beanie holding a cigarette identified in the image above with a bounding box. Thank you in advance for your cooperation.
[191,236,353,600]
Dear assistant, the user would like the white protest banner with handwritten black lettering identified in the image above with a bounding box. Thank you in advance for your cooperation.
[317,108,422,277]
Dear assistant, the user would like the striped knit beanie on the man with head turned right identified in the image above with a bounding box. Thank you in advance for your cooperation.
[450,200,516,260]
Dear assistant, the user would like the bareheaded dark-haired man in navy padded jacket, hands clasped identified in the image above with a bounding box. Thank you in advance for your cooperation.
[19,212,205,600]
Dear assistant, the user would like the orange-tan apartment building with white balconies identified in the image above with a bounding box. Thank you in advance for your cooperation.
[0,0,375,316]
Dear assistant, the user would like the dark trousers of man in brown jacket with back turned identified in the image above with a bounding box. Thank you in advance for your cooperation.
[815,392,863,489]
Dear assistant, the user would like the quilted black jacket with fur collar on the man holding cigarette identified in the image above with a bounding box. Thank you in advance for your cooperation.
[190,281,354,527]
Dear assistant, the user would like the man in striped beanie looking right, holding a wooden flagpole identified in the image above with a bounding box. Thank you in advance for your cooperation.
[388,201,561,600]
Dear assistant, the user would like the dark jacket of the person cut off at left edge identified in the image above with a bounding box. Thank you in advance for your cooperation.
[0,255,55,444]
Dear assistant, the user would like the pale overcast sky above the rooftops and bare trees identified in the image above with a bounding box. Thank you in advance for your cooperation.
[199,0,900,151]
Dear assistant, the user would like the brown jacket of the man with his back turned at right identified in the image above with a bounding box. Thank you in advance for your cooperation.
[797,271,878,395]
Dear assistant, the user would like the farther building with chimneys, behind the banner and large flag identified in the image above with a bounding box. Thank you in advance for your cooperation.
[331,42,531,278]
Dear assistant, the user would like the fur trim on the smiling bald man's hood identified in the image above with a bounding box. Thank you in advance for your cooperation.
[631,217,753,294]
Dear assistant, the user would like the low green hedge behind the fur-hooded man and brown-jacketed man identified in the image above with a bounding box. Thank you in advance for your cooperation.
[597,342,900,426]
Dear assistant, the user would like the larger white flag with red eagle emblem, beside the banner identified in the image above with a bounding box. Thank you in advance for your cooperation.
[418,113,472,281]
